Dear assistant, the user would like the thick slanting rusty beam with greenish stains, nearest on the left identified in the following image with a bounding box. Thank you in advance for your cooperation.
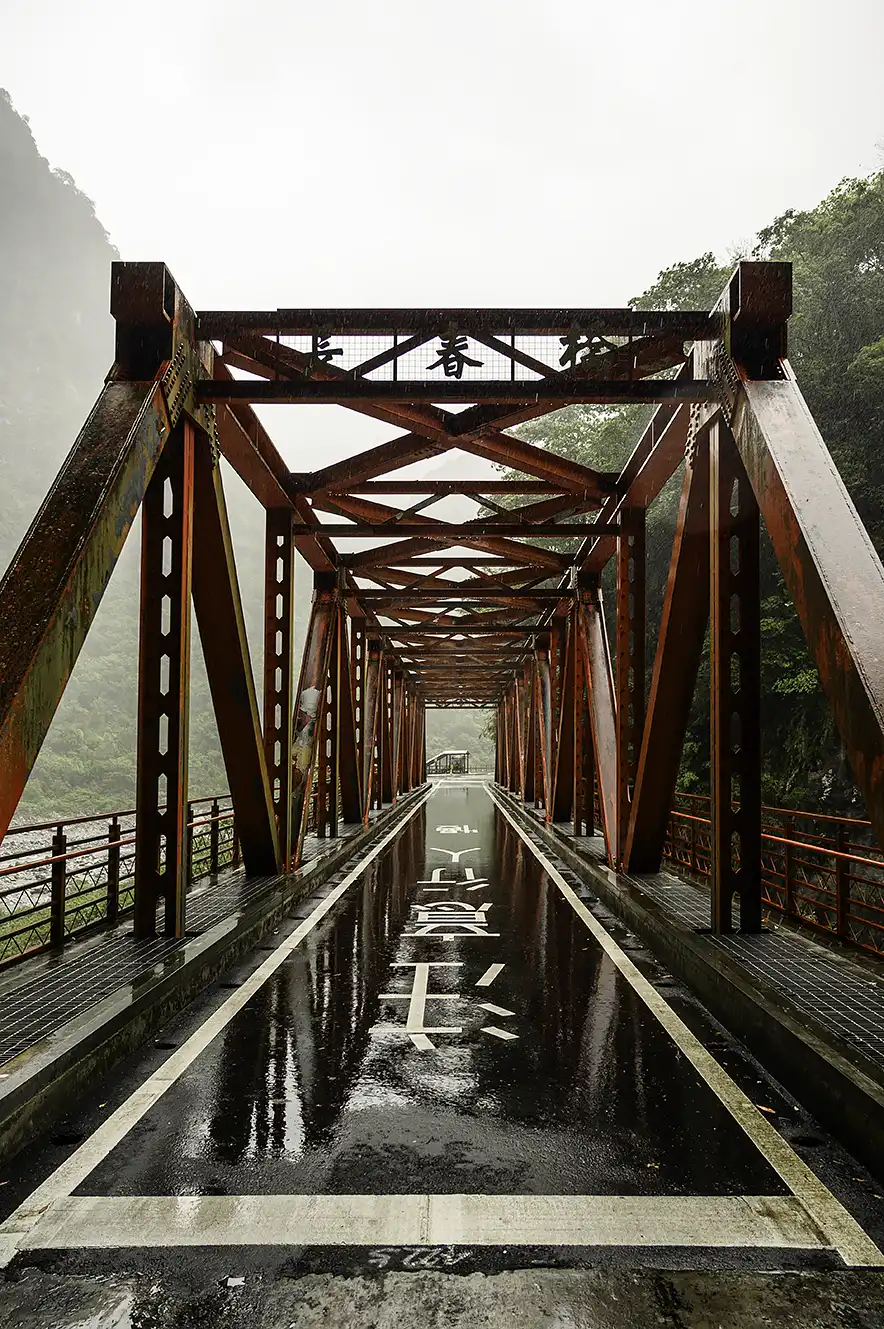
[0,383,171,839]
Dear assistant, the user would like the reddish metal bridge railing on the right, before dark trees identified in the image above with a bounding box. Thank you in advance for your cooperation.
[665,793,884,956]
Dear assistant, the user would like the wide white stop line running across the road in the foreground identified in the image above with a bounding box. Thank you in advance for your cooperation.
[20,1195,827,1249]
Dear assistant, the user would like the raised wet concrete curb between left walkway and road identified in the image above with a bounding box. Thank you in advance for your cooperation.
[0,785,425,1163]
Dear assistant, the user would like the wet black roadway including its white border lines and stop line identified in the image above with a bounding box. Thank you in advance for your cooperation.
[0,781,880,1271]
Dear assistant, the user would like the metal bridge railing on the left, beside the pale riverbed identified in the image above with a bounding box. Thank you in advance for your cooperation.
[0,795,233,968]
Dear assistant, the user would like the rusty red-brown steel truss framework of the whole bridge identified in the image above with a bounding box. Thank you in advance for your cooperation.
[0,263,884,936]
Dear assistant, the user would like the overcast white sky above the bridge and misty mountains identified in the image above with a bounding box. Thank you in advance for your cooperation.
[0,0,884,473]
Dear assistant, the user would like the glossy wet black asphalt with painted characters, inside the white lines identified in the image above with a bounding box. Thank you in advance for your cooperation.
[81,785,784,1195]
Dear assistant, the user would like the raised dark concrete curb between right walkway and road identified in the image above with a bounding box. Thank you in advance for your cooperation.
[495,785,884,1172]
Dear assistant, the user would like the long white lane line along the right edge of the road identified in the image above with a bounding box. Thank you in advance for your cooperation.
[488,788,884,1267]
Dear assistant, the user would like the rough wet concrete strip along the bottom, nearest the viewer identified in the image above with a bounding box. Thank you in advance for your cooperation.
[0,1269,884,1329]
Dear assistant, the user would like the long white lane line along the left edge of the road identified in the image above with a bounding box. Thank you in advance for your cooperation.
[0,788,435,1269]
